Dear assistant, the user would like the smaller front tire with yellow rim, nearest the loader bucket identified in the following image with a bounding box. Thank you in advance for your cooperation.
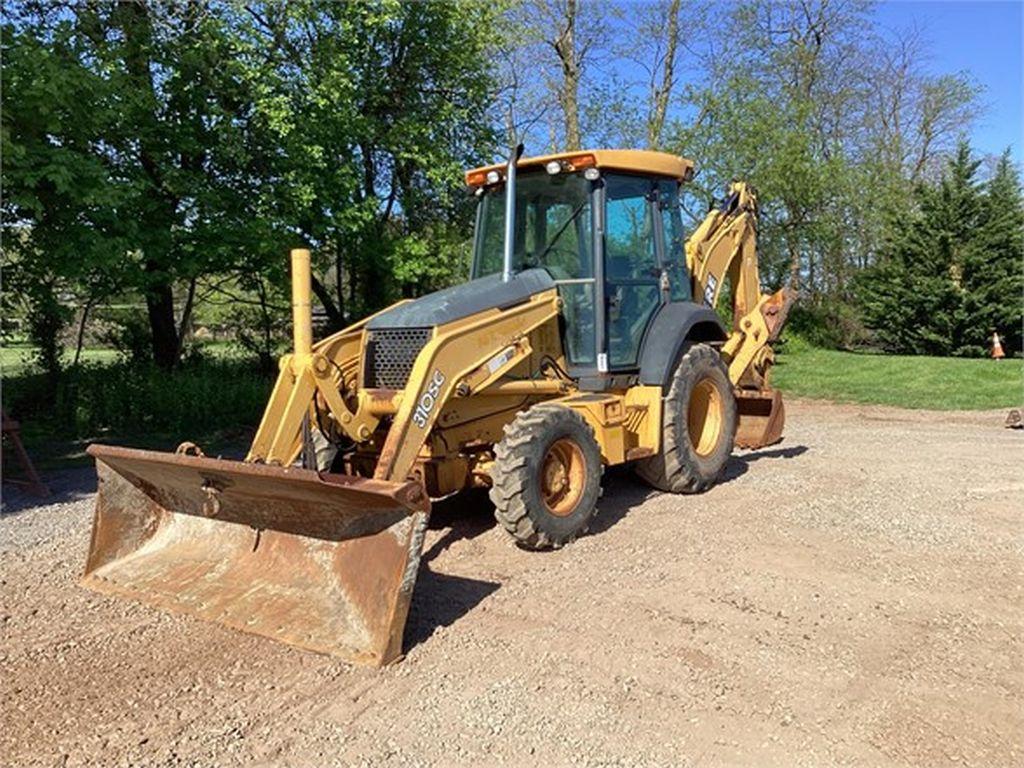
[490,403,601,549]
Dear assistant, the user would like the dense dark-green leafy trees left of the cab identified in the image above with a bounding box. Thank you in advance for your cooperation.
[3,0,495,368]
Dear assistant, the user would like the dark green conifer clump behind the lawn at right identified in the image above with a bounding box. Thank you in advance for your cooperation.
[859,141,1007,355]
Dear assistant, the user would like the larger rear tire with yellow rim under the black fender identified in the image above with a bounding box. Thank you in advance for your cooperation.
[634,344,737,494]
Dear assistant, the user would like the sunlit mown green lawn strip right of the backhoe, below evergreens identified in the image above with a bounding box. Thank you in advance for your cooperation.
[772,338,1024,411]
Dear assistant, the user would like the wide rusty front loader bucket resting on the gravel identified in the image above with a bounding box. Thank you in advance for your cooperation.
[82,445,430,666]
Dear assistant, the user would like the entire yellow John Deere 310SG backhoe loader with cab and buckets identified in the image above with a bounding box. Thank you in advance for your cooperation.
[83,150,793,665]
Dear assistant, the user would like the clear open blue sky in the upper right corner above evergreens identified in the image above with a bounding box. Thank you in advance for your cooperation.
[876,0,1024,163]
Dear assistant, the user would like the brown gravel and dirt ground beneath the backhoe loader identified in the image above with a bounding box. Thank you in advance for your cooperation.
[0,402,1024,767]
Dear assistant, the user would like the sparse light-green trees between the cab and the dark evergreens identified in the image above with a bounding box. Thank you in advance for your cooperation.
[655,0,978,344]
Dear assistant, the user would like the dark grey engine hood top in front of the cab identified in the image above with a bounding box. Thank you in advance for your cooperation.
[367,268,555,331]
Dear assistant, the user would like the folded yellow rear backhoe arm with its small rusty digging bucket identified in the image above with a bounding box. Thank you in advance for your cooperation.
[686,181,797,447]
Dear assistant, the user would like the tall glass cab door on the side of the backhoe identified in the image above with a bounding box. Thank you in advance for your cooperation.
[604,174,665,371]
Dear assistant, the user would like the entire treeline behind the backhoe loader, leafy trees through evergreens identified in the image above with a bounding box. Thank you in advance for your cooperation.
[2,0,1024,382]
